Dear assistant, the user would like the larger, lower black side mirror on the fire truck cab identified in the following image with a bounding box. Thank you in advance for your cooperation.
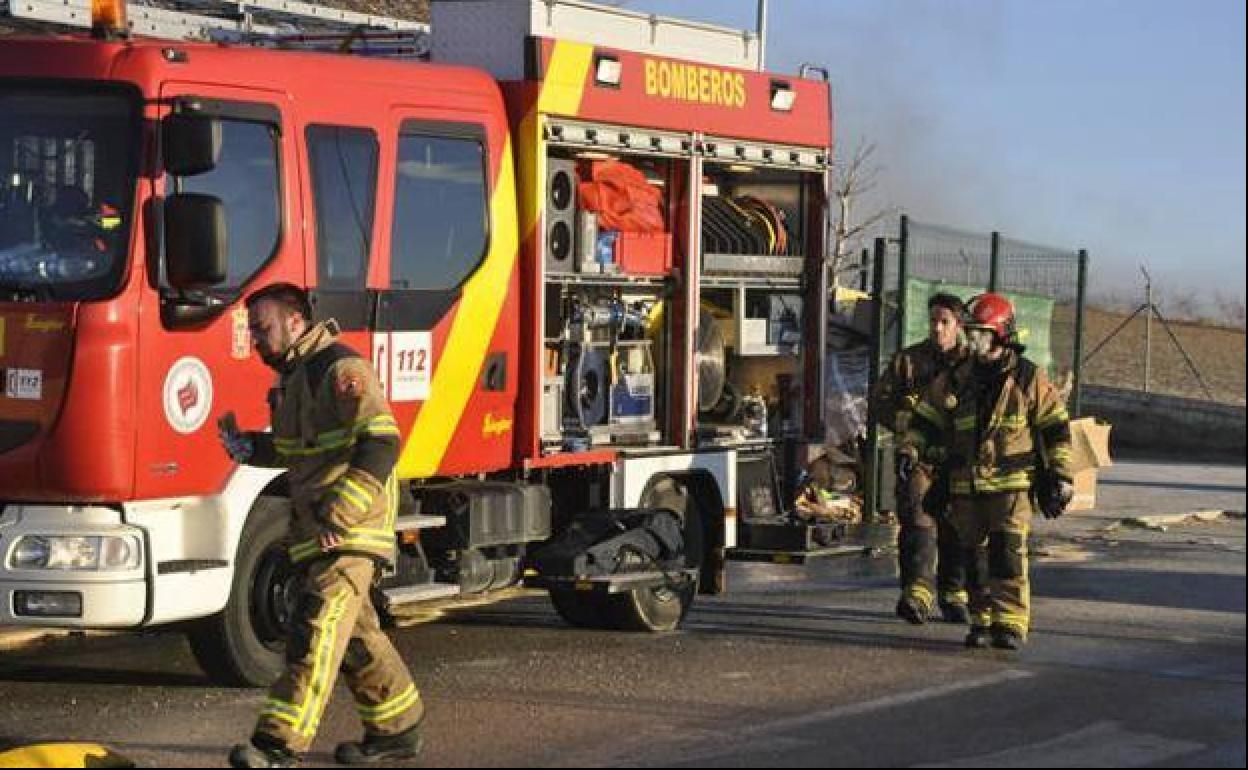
[165,192,230,291]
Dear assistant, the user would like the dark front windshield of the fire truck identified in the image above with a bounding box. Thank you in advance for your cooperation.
[0,81,139,301]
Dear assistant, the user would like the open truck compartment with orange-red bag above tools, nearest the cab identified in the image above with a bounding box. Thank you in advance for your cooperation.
[542,121,690,453]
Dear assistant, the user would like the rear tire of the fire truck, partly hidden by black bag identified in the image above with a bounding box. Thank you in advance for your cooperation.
[603,479,705,633]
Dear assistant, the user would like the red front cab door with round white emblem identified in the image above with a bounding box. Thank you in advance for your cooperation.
[136,82,306,499]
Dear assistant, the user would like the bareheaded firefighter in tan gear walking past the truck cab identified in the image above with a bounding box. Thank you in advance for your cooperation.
[221,283,424,768]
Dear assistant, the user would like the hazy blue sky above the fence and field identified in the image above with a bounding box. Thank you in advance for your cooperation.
[620,0,1246,298]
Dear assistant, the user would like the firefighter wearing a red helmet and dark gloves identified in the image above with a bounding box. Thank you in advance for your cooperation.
[902,293,1075,649]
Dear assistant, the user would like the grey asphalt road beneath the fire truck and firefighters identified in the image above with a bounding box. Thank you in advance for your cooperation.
[0,463,1246,768]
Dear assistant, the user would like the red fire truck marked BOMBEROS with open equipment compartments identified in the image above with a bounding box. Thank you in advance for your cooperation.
[0,0,831,684]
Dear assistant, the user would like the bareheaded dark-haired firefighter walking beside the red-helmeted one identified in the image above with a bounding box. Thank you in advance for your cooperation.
[874,293,970,624]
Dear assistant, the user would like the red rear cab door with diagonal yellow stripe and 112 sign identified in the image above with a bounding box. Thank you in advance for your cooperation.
[373,110,519,478]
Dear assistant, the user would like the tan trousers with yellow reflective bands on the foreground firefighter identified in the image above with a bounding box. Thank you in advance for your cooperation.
[255,555,424,753]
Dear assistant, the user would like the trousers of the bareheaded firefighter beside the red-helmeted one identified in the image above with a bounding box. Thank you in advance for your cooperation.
[897,469,970,610]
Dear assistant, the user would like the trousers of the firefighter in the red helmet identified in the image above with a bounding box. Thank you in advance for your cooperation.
[950,492,1031,636]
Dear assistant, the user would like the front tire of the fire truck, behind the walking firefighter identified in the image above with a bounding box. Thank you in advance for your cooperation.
[187,497,295,688]
